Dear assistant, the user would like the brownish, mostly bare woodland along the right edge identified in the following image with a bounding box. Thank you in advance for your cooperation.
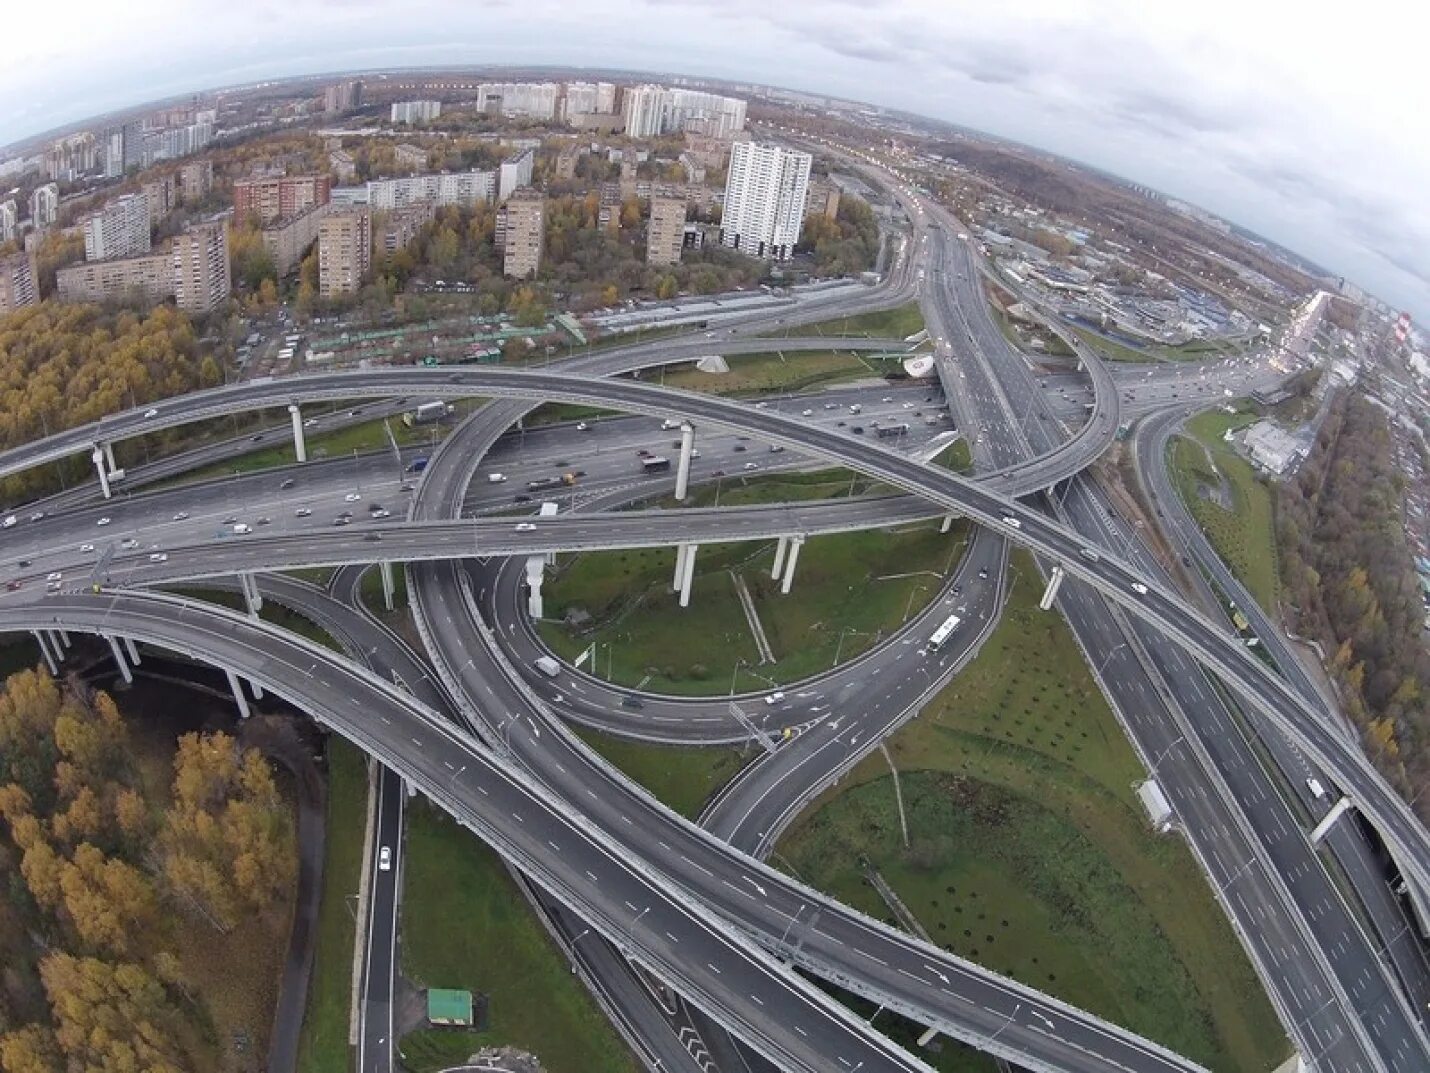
[1277,395,1430,818]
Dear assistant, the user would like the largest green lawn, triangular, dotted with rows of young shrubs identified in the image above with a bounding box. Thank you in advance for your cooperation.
[781,555,1287,1073]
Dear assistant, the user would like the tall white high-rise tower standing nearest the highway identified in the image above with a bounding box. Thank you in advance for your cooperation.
[721,142,811,260]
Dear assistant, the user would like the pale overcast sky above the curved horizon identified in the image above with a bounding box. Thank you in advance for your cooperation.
[0,0,1430,323]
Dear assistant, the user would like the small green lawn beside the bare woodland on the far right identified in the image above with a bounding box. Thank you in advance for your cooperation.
[1171,411,1280,615]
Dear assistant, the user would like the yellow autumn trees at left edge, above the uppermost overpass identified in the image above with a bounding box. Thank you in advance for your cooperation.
[0,302,215,498]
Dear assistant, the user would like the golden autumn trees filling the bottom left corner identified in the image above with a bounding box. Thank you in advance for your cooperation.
[0,671,297,1073]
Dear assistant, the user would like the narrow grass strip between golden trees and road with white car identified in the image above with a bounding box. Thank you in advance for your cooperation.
[297,735,368,1073]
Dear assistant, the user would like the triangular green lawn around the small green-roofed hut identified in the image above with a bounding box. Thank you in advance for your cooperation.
[402,798,636,1073]
